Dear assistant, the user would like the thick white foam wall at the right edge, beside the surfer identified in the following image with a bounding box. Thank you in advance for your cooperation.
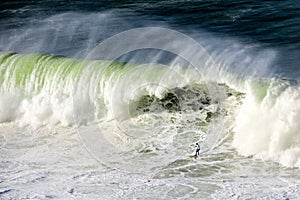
[233,81,300,167]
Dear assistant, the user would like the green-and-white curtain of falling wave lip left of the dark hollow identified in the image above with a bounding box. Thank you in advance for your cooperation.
[0,52,212,123]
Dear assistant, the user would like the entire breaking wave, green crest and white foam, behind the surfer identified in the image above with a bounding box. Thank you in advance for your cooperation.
[0,48,300,169]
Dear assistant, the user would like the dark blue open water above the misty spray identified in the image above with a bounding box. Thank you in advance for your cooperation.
[0,0,300,48]
